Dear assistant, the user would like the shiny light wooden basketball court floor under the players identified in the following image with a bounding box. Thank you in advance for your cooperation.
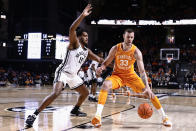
[0,86,196,131]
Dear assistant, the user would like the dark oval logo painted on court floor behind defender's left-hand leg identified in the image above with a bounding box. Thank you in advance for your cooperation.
[5,106,59,113]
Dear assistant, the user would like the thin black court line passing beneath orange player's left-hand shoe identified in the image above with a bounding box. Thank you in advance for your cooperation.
[61,105,135,131]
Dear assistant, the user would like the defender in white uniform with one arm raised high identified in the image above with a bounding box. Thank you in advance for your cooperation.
[25,4,103,127]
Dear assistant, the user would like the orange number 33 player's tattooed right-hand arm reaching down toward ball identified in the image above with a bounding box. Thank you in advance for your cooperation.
[134,48,154,98]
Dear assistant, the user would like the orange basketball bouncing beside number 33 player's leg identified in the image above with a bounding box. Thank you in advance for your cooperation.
[137,103,153,119]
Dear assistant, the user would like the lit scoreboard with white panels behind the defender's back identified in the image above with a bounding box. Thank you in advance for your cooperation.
[13,32,65,60]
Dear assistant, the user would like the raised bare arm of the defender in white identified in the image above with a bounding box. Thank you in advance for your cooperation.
[69,4,92,49]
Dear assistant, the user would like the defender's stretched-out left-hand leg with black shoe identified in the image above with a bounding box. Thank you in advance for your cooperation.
[25,81,64,127]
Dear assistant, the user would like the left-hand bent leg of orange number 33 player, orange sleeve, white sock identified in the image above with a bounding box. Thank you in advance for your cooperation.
[91,75,122,127]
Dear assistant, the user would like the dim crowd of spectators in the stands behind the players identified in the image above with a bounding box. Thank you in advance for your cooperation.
[0,50,196,87]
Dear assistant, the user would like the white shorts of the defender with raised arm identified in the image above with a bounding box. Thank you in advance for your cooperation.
[54,70,84,89]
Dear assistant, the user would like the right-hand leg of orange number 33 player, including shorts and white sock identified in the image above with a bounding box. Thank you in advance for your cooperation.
[126,75,172,126]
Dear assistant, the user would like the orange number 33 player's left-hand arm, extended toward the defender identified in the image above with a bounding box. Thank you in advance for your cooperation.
[96,46,117,75]
